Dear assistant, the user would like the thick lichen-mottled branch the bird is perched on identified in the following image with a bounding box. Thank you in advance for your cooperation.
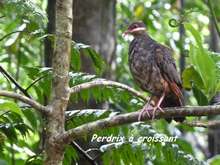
[56,105,220,144]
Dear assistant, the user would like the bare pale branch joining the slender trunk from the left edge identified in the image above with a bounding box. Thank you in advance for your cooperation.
[0,90,49,114]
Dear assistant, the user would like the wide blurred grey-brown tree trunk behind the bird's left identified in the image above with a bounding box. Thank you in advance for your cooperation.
[73,0,116,165]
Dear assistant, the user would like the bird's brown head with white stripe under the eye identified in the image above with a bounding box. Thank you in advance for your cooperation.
[124,21,146,36]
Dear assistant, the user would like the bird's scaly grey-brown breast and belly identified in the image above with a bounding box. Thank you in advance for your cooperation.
[129,39,164,95]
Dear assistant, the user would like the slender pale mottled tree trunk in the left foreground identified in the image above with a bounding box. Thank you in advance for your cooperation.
[45,0,72,165]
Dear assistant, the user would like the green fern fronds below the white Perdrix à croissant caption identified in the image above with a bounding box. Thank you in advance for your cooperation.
[101,123,204,165]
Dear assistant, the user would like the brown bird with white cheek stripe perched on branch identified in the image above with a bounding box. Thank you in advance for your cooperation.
[124,21,185,122]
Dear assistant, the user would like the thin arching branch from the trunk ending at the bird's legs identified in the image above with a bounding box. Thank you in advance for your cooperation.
[70,79,147,102]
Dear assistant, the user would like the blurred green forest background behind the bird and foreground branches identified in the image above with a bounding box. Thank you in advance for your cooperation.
[0,0,220,165]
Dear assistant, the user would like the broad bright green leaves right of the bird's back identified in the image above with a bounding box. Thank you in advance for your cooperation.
[183,24,220,105]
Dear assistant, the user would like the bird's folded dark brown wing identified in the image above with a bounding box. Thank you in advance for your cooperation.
[154,44,182,87]
